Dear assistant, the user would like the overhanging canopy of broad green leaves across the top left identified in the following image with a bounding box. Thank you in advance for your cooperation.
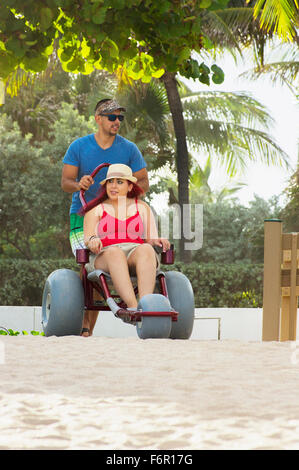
[0,0,227,84]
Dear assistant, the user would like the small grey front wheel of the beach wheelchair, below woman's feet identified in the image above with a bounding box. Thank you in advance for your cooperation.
[136,294,172,339]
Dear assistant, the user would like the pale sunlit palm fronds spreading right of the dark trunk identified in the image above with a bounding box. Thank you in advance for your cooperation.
[182,86,288,175]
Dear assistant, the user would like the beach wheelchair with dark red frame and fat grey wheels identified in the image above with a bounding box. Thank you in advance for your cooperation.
[42,163,194,339]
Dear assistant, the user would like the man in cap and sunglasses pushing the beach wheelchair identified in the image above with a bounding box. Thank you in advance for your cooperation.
[61,99,149,336]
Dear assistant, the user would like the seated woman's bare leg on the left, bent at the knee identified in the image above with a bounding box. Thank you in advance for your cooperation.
[94,246,137,308]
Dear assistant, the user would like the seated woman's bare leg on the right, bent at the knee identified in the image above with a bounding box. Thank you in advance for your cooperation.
[128,243,157,299]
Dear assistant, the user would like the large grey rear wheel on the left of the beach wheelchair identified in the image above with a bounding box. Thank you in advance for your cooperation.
[42,269,84,336]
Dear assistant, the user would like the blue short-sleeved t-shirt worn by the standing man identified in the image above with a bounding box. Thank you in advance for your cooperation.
[63,134,146,214]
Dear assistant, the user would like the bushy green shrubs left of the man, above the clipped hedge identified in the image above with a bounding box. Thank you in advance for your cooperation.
[0,103,94,259]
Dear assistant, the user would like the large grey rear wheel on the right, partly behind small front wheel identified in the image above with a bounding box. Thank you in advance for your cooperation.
[165,271,194,339]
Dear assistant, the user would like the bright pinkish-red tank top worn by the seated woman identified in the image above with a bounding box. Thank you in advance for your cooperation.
[97,199,144,247]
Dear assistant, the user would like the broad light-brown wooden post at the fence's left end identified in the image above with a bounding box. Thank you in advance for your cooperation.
[262,219,282,341]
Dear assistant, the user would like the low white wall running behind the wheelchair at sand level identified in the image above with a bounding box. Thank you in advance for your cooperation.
[0,306,263,341]
